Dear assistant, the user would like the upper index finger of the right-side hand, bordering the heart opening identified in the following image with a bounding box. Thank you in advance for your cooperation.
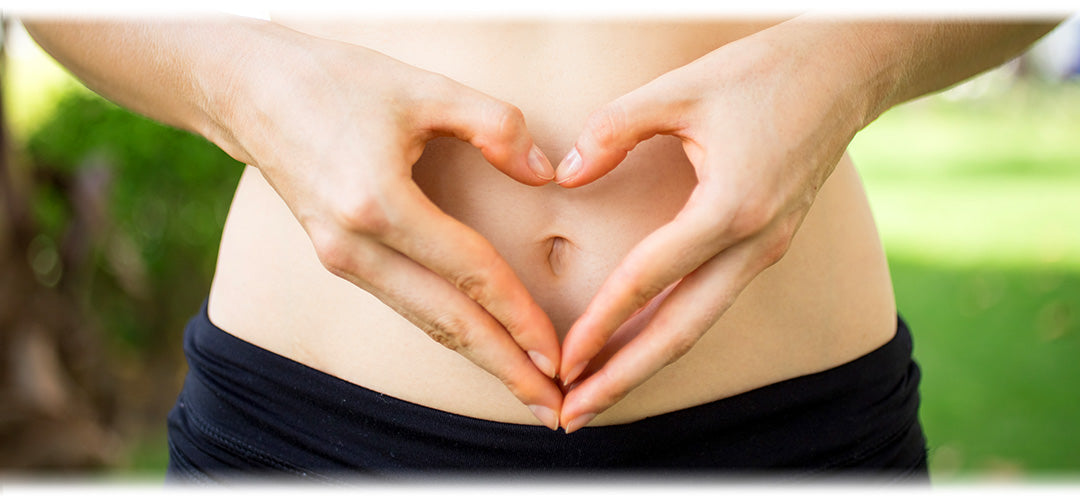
[559,186,739,383]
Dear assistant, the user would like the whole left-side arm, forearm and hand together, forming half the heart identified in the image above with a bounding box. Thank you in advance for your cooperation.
[25,18,563,428]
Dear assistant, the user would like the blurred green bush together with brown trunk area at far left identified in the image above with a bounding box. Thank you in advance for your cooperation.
[0,90,242,470]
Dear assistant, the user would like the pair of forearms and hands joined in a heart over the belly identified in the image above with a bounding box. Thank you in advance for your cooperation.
[27,14,1052,432]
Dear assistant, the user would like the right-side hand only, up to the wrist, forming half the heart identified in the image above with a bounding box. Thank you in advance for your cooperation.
[556,25,864,432]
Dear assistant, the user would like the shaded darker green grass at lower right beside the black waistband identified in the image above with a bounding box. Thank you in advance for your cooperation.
[890,257,1080,479]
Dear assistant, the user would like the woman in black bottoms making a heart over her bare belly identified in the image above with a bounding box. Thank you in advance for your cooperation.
[26,13,1052,479]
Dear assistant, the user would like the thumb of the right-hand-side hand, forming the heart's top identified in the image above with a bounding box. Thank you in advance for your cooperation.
[555,80,686,188]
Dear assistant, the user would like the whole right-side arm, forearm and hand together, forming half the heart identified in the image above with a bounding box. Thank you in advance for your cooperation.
[556,17,1054,432]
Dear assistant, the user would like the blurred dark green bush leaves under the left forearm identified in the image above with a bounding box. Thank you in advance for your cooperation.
[26,92,241,355]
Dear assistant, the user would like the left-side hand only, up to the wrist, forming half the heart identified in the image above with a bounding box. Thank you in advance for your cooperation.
[219,36,563,429]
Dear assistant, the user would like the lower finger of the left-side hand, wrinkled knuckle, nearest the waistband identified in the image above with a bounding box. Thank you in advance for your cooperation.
[315,228,563,429]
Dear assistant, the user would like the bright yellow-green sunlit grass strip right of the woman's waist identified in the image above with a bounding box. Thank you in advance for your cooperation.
[851,84,1080,270]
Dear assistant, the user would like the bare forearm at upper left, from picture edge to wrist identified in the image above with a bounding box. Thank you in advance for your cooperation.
[23,17,313,161]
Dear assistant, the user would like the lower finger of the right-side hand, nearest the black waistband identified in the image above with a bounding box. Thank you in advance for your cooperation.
[559,236,764,433]
